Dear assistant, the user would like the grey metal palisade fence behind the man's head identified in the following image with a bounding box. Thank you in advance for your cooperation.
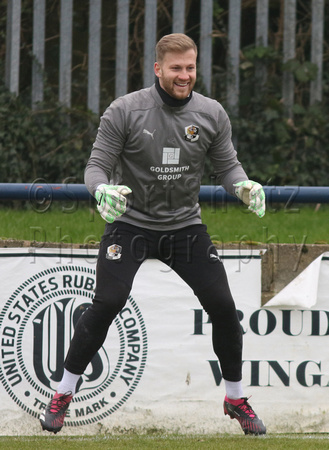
[6,0,325,114]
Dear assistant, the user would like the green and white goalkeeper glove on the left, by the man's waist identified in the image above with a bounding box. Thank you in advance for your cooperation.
[95,184,132,223]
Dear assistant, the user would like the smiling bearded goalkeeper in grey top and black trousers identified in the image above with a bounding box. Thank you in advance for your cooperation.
[40,34,266,435]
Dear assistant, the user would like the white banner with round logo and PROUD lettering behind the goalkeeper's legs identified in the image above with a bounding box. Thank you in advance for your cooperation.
[0,249,329,435]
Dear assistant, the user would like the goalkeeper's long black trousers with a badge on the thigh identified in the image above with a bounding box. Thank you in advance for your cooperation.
[65,221,242,381]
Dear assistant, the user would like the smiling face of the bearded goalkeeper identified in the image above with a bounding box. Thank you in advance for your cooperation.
[154,49,196,100]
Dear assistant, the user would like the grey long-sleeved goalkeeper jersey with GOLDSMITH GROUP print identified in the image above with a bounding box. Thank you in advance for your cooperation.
[85,85,248,231]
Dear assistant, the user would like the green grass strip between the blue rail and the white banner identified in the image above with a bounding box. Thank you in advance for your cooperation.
[0,204,329,244]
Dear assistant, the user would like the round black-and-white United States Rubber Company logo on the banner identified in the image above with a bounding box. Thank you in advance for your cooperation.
[0,266,147,426]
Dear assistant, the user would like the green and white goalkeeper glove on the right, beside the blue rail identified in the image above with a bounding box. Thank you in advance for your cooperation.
[233,180,266,218]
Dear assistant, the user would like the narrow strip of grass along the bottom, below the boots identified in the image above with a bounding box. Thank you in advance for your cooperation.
[0,434,329,450]
